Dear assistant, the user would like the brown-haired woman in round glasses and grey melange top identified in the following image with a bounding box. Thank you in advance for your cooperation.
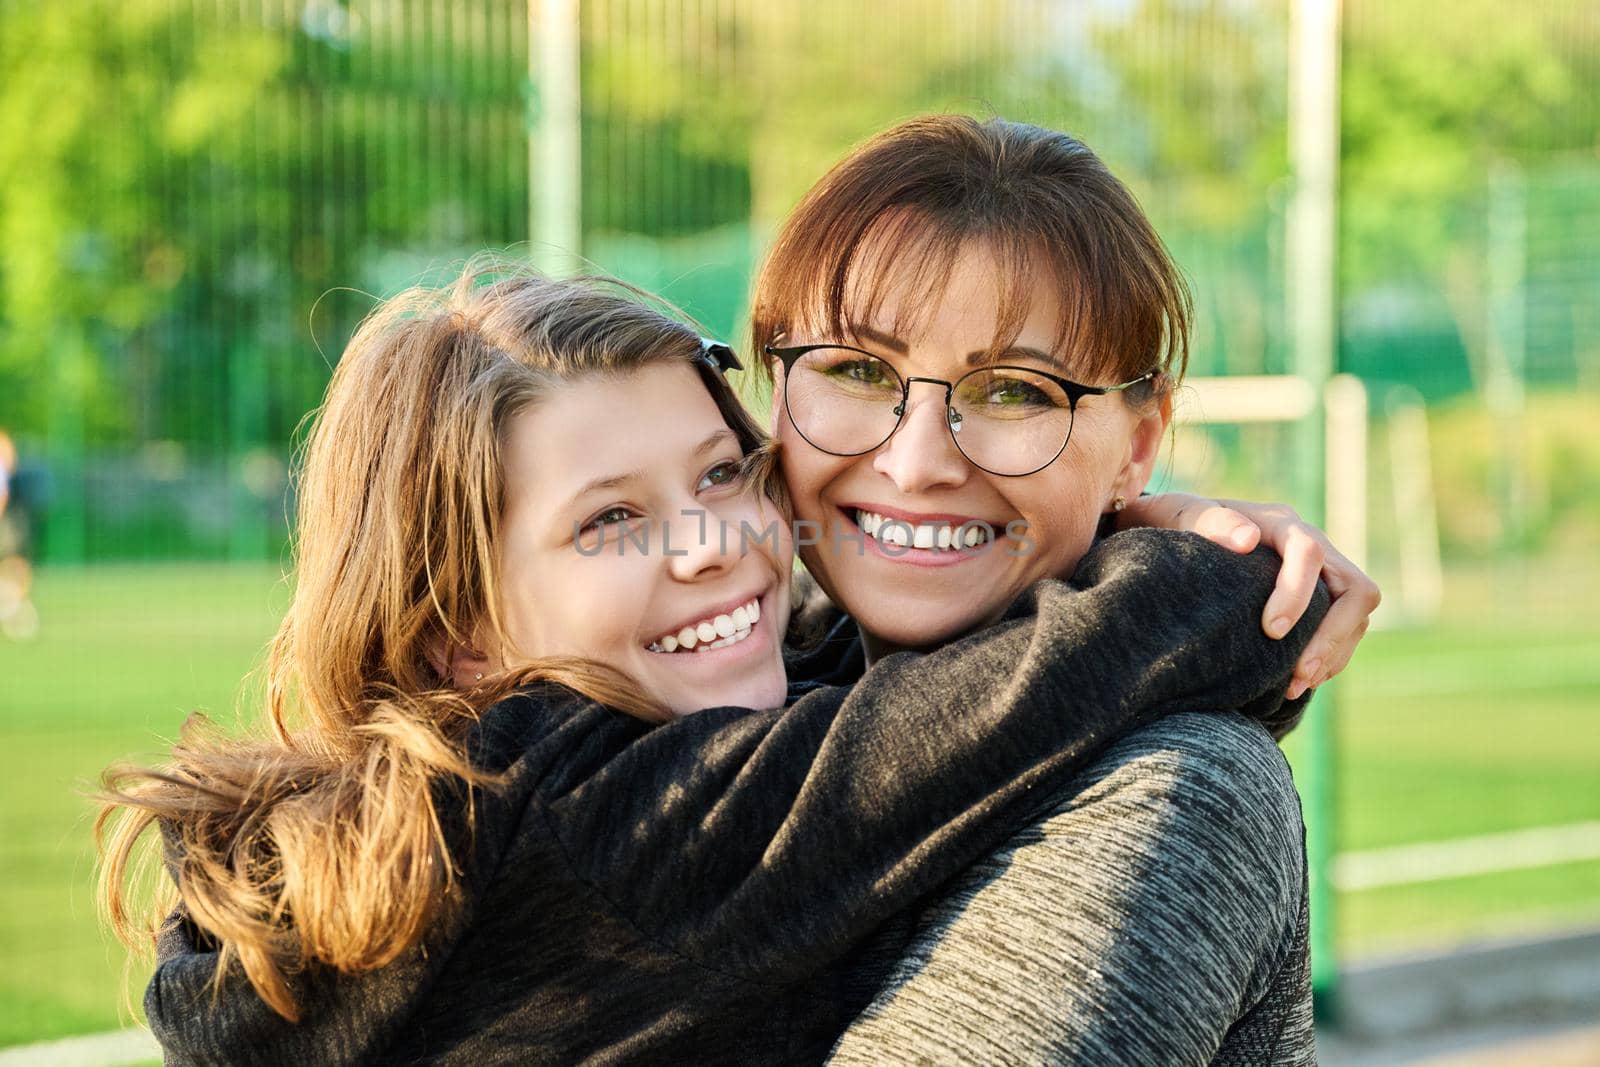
[752,117,1378,1064]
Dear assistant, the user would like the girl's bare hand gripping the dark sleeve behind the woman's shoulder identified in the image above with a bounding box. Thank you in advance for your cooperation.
[1117,493,1382,701]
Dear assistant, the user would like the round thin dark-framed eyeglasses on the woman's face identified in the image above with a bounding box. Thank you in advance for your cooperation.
[765,344,1158,478]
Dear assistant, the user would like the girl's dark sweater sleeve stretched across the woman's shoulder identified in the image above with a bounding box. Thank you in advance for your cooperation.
[536,531,1326,982]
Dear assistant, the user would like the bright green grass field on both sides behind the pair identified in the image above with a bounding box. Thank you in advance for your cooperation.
[0,563,1600,1046]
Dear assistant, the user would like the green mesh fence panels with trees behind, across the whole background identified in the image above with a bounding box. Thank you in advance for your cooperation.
[0,0,1600,560]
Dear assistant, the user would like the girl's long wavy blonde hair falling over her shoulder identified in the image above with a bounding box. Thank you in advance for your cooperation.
[96,259,773,1019]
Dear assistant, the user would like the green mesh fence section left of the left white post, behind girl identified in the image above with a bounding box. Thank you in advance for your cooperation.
[0,0,528,560]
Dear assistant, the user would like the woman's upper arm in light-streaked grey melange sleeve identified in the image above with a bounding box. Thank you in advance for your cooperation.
[834,715,1314,1065]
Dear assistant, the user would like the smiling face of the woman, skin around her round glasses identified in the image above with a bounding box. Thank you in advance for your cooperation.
[773,245,1165,648]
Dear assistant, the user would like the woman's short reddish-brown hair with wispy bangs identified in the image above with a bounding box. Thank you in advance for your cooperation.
[750,115,1194,397]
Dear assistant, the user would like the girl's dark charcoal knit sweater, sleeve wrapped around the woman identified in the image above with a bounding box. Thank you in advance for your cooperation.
[146,531,1326,1065]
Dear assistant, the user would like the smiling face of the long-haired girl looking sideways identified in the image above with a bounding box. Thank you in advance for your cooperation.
[491,363,792,715]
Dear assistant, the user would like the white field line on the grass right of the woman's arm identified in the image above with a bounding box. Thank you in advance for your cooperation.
[1330,822,1600,893]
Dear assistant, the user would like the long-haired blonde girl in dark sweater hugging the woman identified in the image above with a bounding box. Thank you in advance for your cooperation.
[102,262,1325,1064]
